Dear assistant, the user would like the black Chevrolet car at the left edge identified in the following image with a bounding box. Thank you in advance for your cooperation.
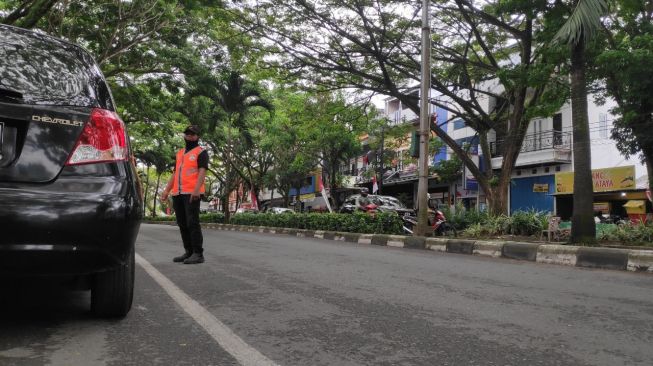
[0,25,142,316]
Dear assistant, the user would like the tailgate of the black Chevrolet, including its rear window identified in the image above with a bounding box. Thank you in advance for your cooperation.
[0,27,112,183]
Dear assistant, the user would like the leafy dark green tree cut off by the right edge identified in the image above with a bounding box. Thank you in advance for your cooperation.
[595,0,653,197]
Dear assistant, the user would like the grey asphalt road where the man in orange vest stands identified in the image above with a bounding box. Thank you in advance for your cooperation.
[0,225,653,366]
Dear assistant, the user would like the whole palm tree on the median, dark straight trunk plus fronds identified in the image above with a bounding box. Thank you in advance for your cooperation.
[554,0,608,243]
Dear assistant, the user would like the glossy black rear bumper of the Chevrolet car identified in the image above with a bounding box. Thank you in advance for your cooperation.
[0,163,142,275]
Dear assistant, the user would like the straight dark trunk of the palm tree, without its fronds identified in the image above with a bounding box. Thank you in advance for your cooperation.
[571,37,596,243]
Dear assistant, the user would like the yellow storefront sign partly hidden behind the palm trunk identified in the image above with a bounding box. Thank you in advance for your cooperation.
[555,165,636,194]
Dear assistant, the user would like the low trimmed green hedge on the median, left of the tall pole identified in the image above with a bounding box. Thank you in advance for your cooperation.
[230,213,403,234]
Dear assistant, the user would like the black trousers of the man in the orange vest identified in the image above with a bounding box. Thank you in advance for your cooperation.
[172,194,204,254]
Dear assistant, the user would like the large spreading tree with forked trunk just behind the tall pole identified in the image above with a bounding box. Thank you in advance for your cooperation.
[237,0,565,213]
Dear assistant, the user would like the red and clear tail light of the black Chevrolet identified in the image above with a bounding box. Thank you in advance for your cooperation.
[66,108,129,165]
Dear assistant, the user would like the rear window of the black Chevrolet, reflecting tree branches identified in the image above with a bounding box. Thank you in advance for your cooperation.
[0,27,110,107]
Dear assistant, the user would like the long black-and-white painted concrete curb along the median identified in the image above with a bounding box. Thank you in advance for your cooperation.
[144,221,653,274]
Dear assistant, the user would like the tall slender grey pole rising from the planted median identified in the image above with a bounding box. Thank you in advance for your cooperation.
[415,0,431,236]
